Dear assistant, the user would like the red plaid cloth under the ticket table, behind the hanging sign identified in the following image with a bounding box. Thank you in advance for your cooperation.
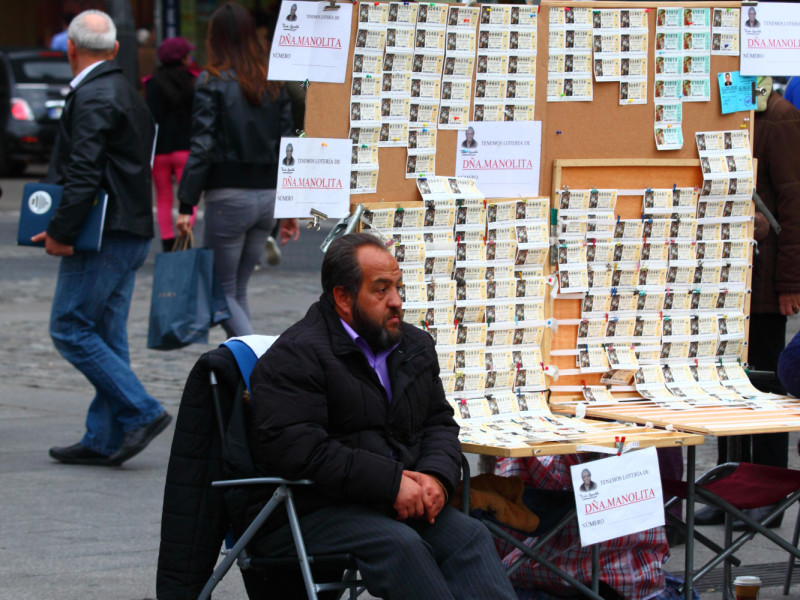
[495,455,669,600]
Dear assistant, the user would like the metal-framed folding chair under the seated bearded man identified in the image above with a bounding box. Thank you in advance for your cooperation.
[199,340,365,600]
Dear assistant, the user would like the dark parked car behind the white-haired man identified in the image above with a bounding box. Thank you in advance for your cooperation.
[0,48,73,175]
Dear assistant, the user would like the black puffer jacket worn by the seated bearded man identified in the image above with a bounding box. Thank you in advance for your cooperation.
[250,299,461,528]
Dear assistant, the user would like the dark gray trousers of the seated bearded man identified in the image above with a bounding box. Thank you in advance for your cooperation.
[254,505,517,600]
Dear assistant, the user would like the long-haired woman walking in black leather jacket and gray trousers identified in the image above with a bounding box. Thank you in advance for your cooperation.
[177,2,299,336]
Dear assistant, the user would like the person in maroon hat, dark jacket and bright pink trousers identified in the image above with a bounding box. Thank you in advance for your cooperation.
[145,37,197,251]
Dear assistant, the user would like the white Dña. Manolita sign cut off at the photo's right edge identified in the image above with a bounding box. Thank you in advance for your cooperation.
[740,2,800,75]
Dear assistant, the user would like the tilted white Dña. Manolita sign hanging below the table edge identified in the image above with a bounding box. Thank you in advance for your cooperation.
[570,448,664,546]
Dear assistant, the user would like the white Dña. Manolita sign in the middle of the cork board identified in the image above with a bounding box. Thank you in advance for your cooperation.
[456,121,542,198]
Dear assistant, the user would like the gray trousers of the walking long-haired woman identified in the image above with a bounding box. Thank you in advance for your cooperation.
[205,188,275,336]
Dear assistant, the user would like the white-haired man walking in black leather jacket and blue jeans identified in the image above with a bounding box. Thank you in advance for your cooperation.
[33,10,172,466]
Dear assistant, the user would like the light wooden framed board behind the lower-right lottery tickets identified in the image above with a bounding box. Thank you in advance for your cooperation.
[547,158,755,398]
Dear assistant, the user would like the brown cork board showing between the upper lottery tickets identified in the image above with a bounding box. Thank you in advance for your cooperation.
[306,0,753,204]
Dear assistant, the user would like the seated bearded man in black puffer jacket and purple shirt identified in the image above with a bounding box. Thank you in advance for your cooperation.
[250,233,516,600]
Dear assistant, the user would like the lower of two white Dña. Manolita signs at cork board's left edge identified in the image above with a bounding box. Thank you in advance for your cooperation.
[275,138,352,219]
